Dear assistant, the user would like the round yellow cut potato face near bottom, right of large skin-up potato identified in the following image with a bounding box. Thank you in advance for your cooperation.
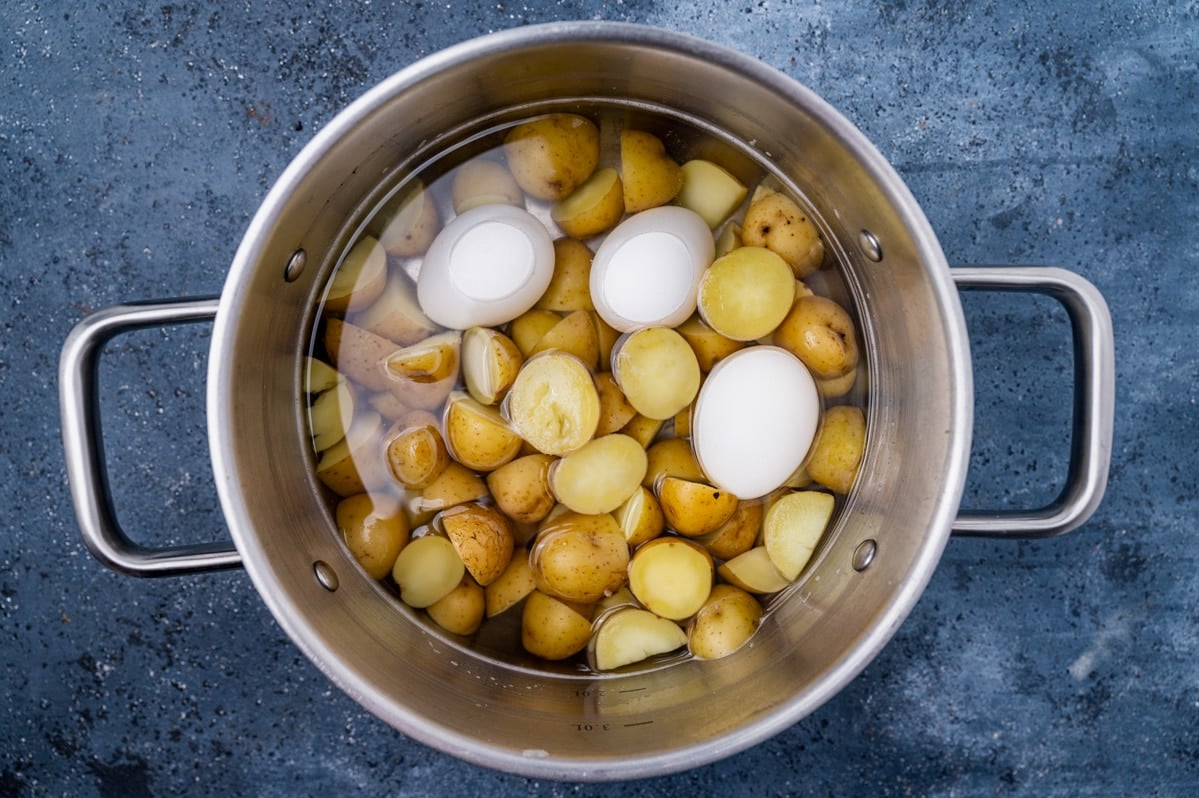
[628,536,715,621]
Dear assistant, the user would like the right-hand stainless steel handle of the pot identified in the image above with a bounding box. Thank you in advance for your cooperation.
[950,266,1115,538]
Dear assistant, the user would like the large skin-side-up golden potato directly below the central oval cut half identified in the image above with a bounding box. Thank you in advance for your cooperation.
[529,510,628,603]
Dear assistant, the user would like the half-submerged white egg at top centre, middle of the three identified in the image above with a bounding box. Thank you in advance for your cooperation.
[591,205,716,332]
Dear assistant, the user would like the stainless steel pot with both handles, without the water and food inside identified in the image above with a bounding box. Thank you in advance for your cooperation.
[60,23,1114,780]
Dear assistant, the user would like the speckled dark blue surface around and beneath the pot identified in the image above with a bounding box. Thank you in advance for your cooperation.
[0,0,1199,797]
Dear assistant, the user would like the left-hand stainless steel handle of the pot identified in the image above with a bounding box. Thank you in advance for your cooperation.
[59,298,241,576]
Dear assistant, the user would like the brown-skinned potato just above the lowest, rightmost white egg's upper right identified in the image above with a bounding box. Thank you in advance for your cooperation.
[773,296,858,380]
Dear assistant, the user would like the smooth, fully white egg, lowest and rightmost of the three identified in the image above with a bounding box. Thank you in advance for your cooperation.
[691,346,820,498]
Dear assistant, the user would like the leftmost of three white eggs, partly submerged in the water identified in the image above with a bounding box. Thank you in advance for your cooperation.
[416,205,554,330]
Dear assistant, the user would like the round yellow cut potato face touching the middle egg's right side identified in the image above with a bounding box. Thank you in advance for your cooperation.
[698,247,795,341]
